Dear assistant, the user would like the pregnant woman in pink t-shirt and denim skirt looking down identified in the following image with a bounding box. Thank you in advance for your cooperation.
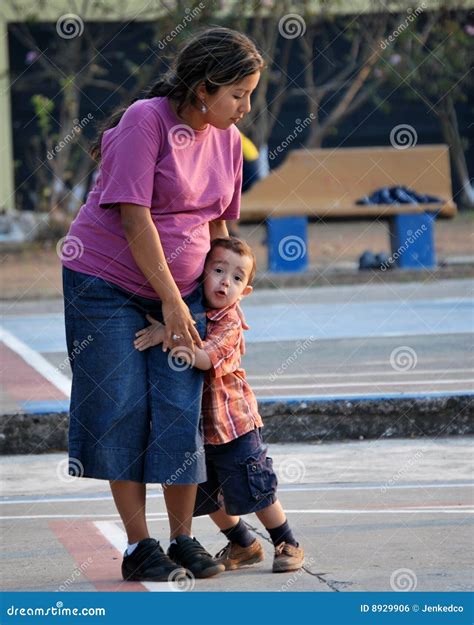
[62,28,264,581]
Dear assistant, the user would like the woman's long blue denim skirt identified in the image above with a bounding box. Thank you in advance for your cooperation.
[63,267,206,484]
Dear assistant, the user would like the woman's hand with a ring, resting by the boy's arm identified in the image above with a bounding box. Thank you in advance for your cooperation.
[162,298,202,352]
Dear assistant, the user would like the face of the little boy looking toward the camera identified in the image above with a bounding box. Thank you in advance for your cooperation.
[204,246,253,308]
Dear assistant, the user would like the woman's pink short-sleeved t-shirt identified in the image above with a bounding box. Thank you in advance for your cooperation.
[62,98,242,299]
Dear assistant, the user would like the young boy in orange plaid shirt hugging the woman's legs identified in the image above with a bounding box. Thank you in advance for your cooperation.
[134,237,304,573]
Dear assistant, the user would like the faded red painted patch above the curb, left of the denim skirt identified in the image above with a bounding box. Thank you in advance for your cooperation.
[0,342,67,402]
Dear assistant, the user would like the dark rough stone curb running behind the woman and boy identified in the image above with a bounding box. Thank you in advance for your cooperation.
[0,393,474,455]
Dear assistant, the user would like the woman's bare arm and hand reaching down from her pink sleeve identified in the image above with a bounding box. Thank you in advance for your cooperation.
[120,204,202,349]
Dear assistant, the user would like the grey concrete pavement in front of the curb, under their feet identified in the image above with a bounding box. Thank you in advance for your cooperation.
[0,437,474,592]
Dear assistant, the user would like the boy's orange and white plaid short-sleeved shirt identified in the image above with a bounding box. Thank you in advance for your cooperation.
[202,304,263,445]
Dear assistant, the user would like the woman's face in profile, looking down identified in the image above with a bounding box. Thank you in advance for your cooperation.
[201,72,260,130]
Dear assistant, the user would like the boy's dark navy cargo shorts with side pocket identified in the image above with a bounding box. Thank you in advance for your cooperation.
[194,429,278,516]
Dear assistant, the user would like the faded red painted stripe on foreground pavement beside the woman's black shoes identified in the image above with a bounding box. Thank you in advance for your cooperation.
[48,521,148,592]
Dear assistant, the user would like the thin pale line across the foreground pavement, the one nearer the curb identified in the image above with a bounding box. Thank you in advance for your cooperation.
[0,482,474,502]
